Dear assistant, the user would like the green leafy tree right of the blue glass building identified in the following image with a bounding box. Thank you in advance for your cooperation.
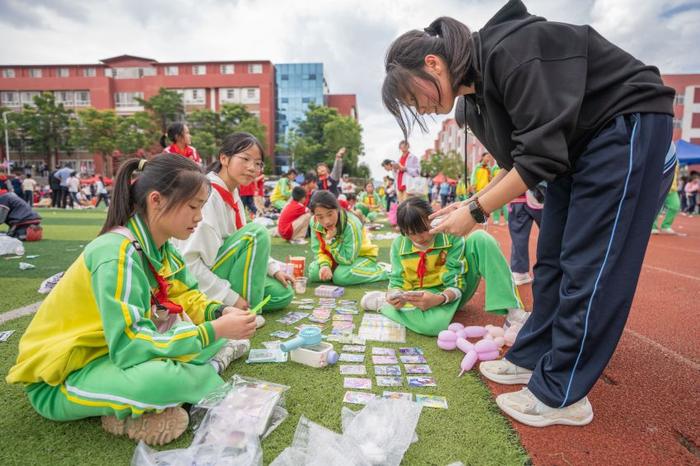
[286,104,362,176]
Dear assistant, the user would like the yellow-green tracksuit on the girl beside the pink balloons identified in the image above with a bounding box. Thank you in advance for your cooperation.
[381,230,522,335]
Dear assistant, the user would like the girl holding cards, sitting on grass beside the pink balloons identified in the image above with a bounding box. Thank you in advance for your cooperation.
[361,197,528,335]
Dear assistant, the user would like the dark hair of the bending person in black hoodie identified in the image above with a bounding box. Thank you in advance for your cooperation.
[382,16,476,139]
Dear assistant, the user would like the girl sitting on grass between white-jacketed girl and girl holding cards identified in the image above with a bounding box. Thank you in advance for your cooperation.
[309,190,387,286]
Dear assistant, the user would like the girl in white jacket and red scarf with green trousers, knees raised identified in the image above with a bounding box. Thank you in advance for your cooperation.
[175,132,294,326]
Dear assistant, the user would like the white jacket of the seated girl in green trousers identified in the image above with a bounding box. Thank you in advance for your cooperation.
[173,172,282,305]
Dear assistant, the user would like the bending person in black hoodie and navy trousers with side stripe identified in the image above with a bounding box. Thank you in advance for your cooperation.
[382,0,675,426]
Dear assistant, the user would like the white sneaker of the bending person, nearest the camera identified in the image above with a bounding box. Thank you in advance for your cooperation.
[496,388,593,427]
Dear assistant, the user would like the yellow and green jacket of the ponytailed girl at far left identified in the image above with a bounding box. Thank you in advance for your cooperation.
[6,215,221,386]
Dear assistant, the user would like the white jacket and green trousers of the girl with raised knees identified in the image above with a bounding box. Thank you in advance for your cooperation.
[178,172,294,311]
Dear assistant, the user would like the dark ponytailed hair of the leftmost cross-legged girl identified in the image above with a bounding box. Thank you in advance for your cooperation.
[100,154,209,234]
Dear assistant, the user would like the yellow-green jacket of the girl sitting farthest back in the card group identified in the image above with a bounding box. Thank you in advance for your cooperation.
[311,212,379,268]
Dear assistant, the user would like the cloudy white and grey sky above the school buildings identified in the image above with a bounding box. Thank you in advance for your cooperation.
[0,0,700,176]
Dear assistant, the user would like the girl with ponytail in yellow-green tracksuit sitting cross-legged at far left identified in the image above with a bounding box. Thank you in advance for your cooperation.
[7,154,255,444]
